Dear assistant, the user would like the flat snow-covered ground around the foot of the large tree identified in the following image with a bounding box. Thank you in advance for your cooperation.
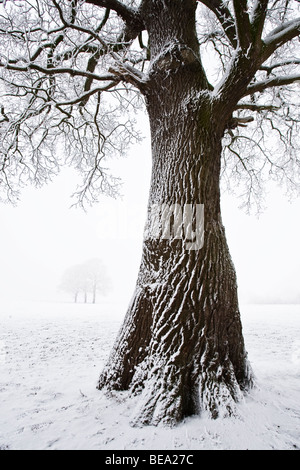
[0,303,300,450]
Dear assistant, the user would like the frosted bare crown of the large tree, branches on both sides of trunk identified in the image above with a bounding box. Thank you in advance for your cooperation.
[0,0,300,209]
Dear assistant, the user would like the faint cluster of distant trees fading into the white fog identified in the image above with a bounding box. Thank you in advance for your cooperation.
[60,258,111,303]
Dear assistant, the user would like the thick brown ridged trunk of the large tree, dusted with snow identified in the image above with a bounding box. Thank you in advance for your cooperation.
[99,0,252,424]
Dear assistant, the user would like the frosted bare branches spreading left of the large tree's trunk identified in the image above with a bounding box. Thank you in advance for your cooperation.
[0,0,145,205]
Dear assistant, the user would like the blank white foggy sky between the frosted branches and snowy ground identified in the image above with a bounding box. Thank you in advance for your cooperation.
[0,119,300,303]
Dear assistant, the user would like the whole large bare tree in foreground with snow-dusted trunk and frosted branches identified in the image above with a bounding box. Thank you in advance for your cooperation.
[0,0,300,425]
